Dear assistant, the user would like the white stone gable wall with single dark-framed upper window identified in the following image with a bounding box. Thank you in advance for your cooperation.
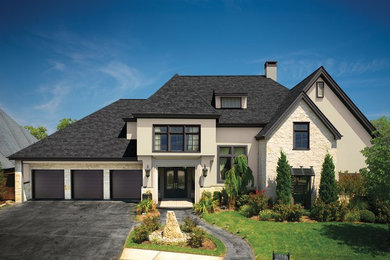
[266,101,337,199]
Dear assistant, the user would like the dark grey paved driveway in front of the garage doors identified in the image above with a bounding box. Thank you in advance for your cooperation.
[0,201,135,259]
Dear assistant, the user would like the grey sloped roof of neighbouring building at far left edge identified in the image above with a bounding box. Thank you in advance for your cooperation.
[0,109,38,169]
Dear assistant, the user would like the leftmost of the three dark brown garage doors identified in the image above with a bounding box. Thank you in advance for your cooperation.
[32,170,64,199]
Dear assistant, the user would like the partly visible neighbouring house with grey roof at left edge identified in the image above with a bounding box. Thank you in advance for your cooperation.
[0,109,37,200]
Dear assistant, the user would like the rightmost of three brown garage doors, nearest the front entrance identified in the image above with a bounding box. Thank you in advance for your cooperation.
[111,170,142,200]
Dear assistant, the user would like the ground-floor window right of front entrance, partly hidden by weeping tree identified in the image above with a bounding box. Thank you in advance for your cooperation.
[218,146,247,182]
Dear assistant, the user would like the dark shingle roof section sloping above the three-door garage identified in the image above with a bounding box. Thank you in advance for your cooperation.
[10,99,144,161]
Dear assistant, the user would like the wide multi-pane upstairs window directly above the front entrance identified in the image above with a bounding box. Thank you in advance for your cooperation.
[153,125,200,152]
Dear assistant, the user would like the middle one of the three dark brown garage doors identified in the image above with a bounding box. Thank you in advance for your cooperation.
[72,170,103,200]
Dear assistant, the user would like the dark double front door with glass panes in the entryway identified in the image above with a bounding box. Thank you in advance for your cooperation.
[164,168,187,198]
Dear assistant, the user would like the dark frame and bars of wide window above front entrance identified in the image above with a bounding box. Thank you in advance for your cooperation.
[152,124,202,153]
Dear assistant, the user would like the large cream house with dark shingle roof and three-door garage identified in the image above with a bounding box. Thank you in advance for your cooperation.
[10,61,374,206]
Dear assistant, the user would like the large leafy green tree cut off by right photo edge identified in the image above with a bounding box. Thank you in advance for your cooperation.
[362,116,390,205]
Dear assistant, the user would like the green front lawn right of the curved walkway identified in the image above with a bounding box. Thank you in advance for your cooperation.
[203,211,390,259]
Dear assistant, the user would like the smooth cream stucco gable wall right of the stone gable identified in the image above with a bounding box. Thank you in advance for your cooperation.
[307,78,371,172]
